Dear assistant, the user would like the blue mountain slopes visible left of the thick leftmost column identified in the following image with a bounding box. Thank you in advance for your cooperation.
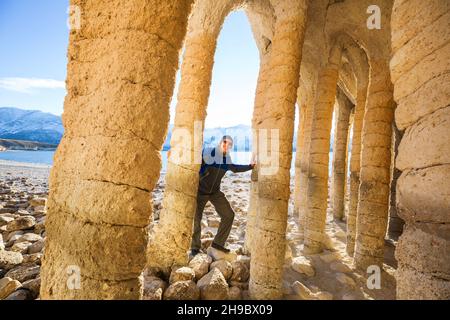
[0,107,64,145]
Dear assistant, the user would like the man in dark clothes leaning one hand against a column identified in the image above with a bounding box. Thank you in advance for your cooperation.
[191,136,255,256]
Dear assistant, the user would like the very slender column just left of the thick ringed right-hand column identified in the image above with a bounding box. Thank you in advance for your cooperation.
[346,84,367,257]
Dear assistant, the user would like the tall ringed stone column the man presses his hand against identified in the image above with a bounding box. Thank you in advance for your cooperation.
[249,0,306,299]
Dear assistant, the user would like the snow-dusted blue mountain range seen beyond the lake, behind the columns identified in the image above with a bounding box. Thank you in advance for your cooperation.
[0,107,297,151]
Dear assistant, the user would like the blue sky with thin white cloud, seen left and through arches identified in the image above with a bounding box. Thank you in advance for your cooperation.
[0,0,259,127]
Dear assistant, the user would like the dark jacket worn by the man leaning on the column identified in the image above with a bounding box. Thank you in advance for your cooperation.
[198,148,253,194]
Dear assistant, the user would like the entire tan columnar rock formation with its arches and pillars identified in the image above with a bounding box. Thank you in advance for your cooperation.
[41,0,450,299]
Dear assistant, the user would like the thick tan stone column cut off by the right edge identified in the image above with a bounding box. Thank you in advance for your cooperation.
[390,0,450,300]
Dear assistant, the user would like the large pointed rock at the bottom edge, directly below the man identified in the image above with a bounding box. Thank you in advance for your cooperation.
[197,268,228,300]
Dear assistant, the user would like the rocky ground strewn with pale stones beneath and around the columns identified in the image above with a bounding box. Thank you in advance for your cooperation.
[0,162,395,300]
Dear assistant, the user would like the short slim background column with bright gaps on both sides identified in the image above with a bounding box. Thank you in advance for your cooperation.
[331,90,352,220]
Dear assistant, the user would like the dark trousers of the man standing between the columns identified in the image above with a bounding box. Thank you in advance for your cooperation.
[191,191,234,250]
